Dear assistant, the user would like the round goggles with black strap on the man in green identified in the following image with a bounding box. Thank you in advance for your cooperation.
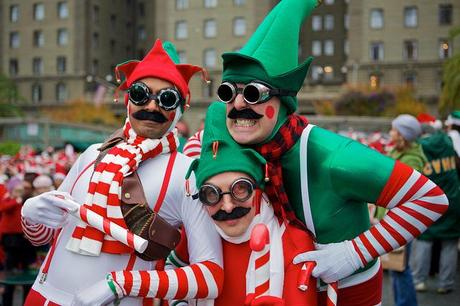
[217,81,297,104]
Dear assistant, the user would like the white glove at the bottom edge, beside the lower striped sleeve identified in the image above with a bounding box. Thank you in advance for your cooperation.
[72,279,117,306]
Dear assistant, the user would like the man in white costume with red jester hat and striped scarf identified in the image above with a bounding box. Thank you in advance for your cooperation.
[18,40,222,306]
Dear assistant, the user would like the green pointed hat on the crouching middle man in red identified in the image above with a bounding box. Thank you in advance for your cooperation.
[186,102,266,188]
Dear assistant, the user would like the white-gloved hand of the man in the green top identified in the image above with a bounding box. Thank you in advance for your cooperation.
[293,240,364,284]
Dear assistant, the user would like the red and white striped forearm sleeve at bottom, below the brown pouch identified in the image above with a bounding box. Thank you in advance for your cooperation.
[112,261,224,300]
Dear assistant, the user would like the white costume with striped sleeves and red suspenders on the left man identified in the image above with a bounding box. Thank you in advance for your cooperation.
[23,145,222,306]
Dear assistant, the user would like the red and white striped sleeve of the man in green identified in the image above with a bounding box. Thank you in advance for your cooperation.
[352,161,449,264]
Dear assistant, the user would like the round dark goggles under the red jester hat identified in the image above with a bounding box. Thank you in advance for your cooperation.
[128,82,184,111]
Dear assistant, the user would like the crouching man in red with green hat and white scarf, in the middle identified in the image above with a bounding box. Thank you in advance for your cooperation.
[171,104,317,306]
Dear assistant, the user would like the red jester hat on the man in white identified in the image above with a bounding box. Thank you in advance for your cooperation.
[115,39,207,111]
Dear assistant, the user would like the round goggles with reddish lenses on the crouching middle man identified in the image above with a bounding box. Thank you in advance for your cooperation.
[193,177,256,206]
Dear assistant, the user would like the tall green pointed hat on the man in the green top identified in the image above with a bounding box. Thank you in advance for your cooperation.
[222,0,322,113]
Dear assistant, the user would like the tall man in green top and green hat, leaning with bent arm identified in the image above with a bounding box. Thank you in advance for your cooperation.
[184,0,448,306]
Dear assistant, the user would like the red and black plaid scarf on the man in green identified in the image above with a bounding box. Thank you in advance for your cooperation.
[255,114,308,228]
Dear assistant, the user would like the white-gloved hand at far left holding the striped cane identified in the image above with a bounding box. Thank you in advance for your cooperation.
[21,190,75,228]
